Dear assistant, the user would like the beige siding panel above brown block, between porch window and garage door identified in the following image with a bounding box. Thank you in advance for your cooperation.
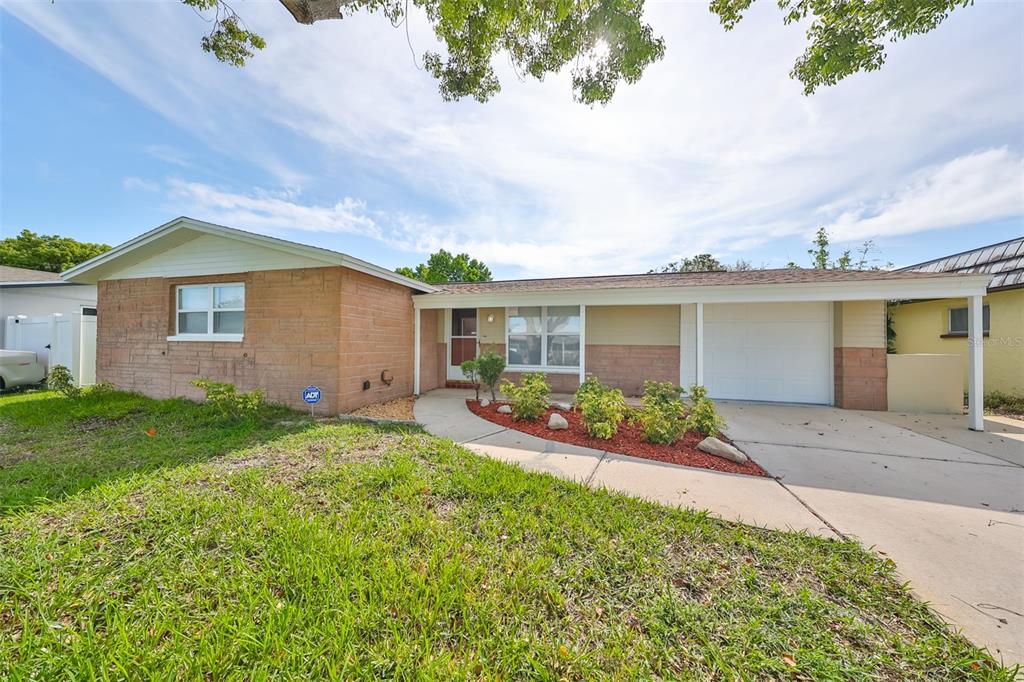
[587,305,679,346]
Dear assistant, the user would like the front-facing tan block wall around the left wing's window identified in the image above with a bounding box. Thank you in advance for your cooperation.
[96,267,342,413]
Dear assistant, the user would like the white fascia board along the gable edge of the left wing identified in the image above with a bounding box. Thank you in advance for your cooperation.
[60,216,437,292]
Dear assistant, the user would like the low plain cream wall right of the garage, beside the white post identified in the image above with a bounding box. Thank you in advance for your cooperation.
[886,353,964,415]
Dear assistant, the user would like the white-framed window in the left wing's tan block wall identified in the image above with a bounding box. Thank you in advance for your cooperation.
[176,284,246,338]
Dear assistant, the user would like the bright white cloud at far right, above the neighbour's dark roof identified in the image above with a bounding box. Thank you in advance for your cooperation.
[829,147,1024,241]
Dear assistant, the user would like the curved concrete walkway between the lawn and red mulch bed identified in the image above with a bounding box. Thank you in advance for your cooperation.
[414,389,835,537]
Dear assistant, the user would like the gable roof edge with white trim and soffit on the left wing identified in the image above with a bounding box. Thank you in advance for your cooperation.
[60,216,436,293]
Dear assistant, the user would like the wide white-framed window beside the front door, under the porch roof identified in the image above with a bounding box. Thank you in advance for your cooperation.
[505,305,580,369]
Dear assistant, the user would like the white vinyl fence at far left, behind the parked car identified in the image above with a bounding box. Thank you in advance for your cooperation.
[4,312,96,386]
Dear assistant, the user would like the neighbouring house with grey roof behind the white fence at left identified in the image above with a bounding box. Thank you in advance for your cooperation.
[0,265,96,348]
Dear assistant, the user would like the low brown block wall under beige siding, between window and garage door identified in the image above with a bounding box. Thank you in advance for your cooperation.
[586,344,679,395]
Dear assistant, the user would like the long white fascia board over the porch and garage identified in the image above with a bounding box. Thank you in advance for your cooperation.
[413,274,989,309]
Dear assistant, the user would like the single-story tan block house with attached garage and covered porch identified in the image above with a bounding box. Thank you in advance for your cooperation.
[63,218,989,429]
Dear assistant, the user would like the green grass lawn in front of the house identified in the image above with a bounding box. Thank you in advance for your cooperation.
[0,385,1013,680]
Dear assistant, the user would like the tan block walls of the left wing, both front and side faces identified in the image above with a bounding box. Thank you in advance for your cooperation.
[96,267,413,414]
